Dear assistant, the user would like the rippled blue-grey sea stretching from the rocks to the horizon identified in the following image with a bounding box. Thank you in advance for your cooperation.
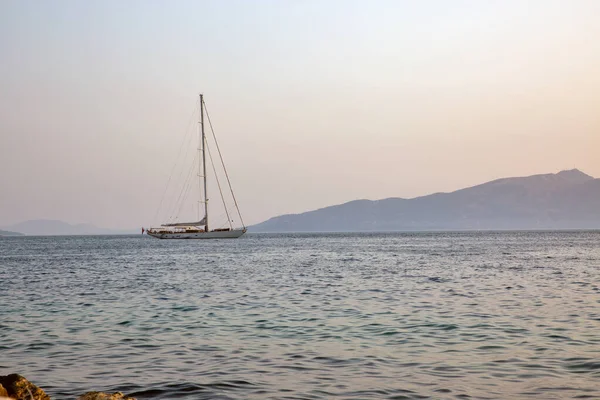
[0,232,600,400]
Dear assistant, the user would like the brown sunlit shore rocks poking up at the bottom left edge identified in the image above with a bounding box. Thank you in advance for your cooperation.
[0,374,136,400]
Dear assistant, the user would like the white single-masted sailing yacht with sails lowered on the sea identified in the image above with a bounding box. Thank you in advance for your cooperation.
[146,94,246,239]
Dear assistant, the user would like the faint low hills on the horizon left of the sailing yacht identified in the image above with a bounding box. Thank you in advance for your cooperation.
[0,219,137,235]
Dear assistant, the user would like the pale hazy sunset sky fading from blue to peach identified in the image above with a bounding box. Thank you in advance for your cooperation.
[0,0,600,228]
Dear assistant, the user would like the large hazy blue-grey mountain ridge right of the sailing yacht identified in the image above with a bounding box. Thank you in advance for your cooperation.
[250,169,600,232]
